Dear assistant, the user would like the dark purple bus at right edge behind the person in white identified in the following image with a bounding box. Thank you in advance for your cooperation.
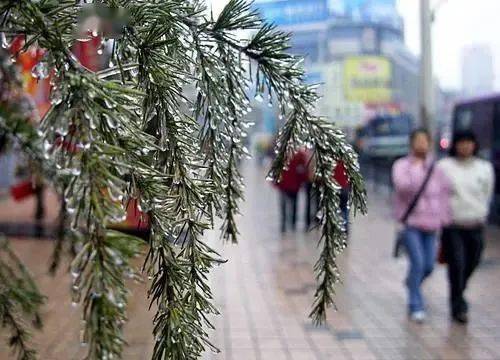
[452,93,500,224]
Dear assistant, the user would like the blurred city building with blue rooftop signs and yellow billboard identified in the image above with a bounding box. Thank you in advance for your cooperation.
[254,0,419,139]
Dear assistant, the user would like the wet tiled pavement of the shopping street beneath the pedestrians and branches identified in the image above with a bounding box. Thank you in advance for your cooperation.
[0,163,500,360]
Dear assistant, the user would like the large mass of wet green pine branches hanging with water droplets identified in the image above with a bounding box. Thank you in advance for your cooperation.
[0,0,366,360]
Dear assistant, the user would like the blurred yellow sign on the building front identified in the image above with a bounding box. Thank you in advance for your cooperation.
[344,56,392,104]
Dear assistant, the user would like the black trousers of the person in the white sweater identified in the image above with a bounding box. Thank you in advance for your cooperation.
[442,226,484,315]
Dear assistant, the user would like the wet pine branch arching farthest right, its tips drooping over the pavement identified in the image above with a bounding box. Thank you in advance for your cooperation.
[203,0,366,323]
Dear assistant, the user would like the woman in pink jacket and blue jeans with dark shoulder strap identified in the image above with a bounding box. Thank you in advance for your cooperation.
[392,129,447,323]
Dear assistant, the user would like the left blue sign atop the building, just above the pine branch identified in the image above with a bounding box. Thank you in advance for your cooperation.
[253,0,329,26]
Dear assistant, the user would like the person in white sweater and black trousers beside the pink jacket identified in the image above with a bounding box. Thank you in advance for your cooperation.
[438,131,494,324]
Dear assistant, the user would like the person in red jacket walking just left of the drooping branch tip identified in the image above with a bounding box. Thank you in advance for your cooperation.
[276,150,308,233]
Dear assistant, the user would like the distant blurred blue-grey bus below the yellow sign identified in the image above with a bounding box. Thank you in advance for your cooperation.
[358,113,414,160]
